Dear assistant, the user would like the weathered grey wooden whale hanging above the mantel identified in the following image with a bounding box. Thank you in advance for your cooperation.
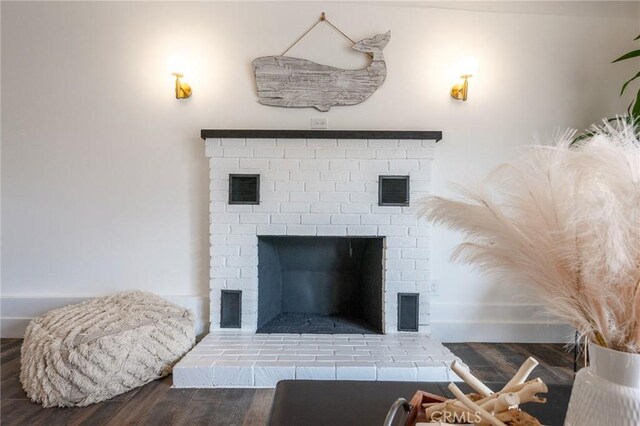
[253,31,391,111]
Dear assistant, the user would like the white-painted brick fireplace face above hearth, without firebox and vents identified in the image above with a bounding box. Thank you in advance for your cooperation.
[205,132,435,333]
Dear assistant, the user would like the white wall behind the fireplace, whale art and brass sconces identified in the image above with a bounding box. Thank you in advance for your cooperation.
[1,2,640,341]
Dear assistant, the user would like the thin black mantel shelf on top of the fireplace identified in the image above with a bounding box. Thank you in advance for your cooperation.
[200,129,442,142]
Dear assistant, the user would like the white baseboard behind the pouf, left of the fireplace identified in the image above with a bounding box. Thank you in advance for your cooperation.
[0,295,209,338]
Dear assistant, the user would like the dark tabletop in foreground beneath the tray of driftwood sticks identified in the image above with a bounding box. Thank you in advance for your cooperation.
[269,380,571,426]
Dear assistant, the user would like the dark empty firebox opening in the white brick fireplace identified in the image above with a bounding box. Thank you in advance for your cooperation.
[258,236,383,334]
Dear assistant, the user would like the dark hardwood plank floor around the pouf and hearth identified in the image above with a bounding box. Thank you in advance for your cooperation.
[0,339,573,426]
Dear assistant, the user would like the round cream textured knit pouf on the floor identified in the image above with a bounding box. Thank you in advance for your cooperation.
[20,291,195,407]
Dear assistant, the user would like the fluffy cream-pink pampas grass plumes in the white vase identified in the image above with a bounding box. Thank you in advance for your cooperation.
[422,120,640,353]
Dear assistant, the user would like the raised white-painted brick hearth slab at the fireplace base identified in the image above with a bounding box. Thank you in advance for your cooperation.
[173,332,460,388]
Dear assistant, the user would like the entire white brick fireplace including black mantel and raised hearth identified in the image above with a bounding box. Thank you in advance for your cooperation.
[174,130,464,387]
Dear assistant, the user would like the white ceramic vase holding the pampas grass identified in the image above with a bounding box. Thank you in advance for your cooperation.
[564,343,640,426]
